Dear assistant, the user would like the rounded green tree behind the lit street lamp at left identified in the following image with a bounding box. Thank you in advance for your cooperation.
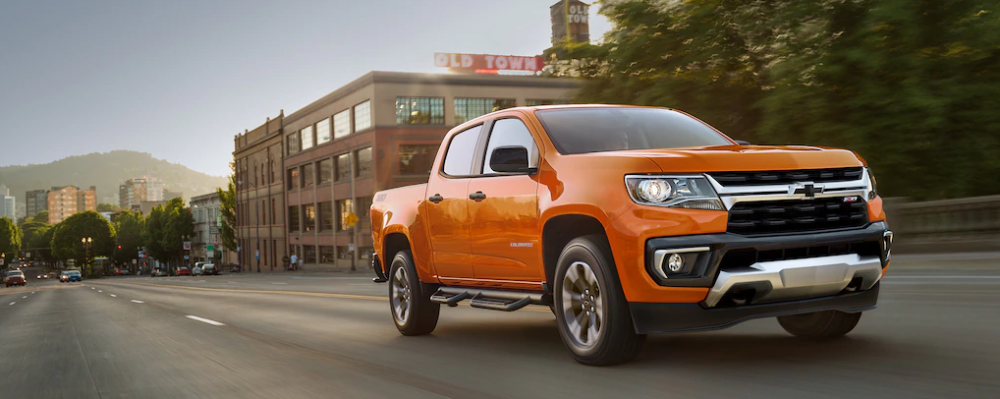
[51,211,115,265]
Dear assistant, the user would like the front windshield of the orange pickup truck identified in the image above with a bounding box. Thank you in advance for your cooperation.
[535,107,732,154]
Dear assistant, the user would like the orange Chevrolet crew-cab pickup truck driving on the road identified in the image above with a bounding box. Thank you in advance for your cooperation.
[371,105,892,365]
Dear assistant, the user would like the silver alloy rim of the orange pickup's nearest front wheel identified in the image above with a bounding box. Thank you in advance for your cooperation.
[562,261,604,348]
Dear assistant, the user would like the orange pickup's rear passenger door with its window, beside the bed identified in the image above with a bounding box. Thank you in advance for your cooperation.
[424,125,482,284]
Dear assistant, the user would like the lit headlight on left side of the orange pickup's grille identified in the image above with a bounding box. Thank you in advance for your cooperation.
[625,176,726,211]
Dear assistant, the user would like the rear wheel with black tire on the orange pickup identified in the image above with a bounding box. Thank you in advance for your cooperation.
[389,250,441,336]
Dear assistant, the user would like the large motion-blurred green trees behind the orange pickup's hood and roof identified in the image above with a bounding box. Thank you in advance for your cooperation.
[547,0,1000,198]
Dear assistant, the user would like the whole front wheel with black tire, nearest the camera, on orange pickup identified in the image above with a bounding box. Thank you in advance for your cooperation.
[553,235,646,366]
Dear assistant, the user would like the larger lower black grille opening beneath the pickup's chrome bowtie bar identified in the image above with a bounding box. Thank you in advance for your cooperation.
[726,197,868,235]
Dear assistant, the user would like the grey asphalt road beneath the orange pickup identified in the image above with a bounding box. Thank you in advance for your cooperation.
[0,258,1000,399]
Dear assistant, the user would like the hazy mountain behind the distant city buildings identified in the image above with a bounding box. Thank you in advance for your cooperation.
[0,150,226,207]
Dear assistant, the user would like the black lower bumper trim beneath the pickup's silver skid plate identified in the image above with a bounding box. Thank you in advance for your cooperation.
[629,283,879,334]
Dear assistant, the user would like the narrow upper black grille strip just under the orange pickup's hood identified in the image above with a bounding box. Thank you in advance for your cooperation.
[709,168,864,187]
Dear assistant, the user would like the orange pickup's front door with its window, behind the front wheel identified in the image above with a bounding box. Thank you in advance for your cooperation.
[469,114,545,289]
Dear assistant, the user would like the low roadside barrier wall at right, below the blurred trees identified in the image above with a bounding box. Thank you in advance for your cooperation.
[884,195,1000,253]
